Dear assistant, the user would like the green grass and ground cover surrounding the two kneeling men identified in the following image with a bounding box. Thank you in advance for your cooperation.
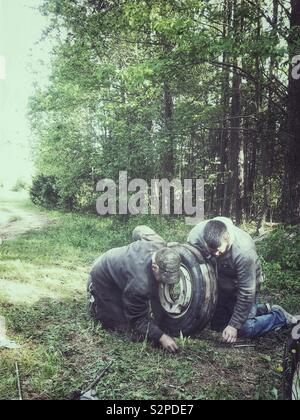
[0,199,300,400]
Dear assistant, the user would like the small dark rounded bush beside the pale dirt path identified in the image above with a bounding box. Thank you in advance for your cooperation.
[30,175,59,209]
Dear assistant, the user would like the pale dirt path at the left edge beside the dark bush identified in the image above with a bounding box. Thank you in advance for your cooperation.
[0,190,52,244]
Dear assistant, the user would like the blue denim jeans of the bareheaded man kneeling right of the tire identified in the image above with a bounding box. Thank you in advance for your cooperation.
[211,292,287,338]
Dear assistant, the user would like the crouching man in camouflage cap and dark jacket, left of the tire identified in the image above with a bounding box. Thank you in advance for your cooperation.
[88,226,180,352]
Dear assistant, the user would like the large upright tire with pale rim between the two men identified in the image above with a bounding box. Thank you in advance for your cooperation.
[151,245,217,336]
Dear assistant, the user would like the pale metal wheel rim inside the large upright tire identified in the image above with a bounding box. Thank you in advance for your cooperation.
[159,265,193,318]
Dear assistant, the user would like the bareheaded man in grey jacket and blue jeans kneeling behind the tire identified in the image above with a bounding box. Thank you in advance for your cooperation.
[188,217,298,343]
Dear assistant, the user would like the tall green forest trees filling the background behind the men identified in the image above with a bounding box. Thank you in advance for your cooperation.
[29,0,300,227]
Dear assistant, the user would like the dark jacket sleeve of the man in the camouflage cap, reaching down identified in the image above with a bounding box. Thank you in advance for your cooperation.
[123,290,164,342]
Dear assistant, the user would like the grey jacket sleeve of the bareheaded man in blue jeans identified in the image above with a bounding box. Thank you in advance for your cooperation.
[229,250,258,330]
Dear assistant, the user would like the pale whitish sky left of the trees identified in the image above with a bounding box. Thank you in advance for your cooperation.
[0,0,51,184]
